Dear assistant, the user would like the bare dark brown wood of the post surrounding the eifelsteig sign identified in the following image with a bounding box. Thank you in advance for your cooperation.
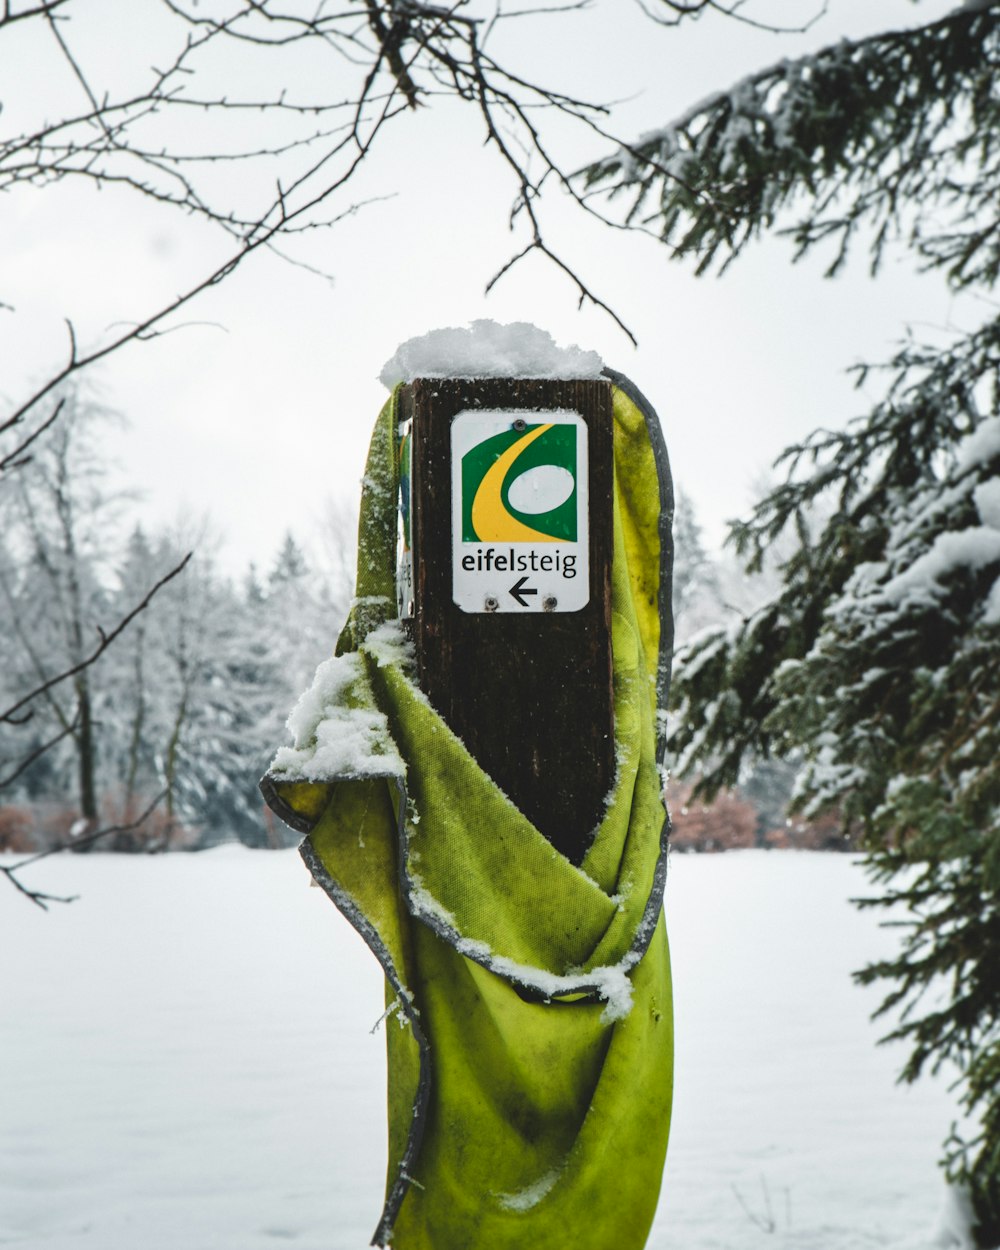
[403,379,615,864]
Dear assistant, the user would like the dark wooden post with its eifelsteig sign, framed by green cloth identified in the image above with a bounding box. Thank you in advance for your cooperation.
[400,379,615,864]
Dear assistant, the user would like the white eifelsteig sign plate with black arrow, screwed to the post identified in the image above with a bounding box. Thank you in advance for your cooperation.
[451,409,590,613]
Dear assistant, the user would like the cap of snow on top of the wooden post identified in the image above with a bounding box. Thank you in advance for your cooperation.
[379,320,604,390]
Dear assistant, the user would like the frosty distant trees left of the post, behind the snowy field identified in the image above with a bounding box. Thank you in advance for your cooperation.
[0,389,350,851]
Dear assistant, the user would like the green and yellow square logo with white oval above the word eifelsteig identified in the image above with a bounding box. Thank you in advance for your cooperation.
[461,423,578,543]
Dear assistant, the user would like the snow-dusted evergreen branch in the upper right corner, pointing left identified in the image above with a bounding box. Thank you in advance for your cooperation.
[580,5,1000,285]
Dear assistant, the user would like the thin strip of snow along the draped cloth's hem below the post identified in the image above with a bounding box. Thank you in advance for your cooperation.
[408,871,641,1024]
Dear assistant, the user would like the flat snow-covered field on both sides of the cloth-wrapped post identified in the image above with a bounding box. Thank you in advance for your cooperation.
[0,846,970,1250]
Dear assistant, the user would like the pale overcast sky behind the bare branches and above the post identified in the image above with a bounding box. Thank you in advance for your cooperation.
[0,0,963,582]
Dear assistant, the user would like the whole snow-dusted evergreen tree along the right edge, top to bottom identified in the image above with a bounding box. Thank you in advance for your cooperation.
[586,0,1000,1246]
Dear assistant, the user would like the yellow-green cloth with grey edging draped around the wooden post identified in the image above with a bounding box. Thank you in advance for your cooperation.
[261,375,673,1250]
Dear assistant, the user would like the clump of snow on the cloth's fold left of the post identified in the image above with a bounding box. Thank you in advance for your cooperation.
[271,650,405,781]
